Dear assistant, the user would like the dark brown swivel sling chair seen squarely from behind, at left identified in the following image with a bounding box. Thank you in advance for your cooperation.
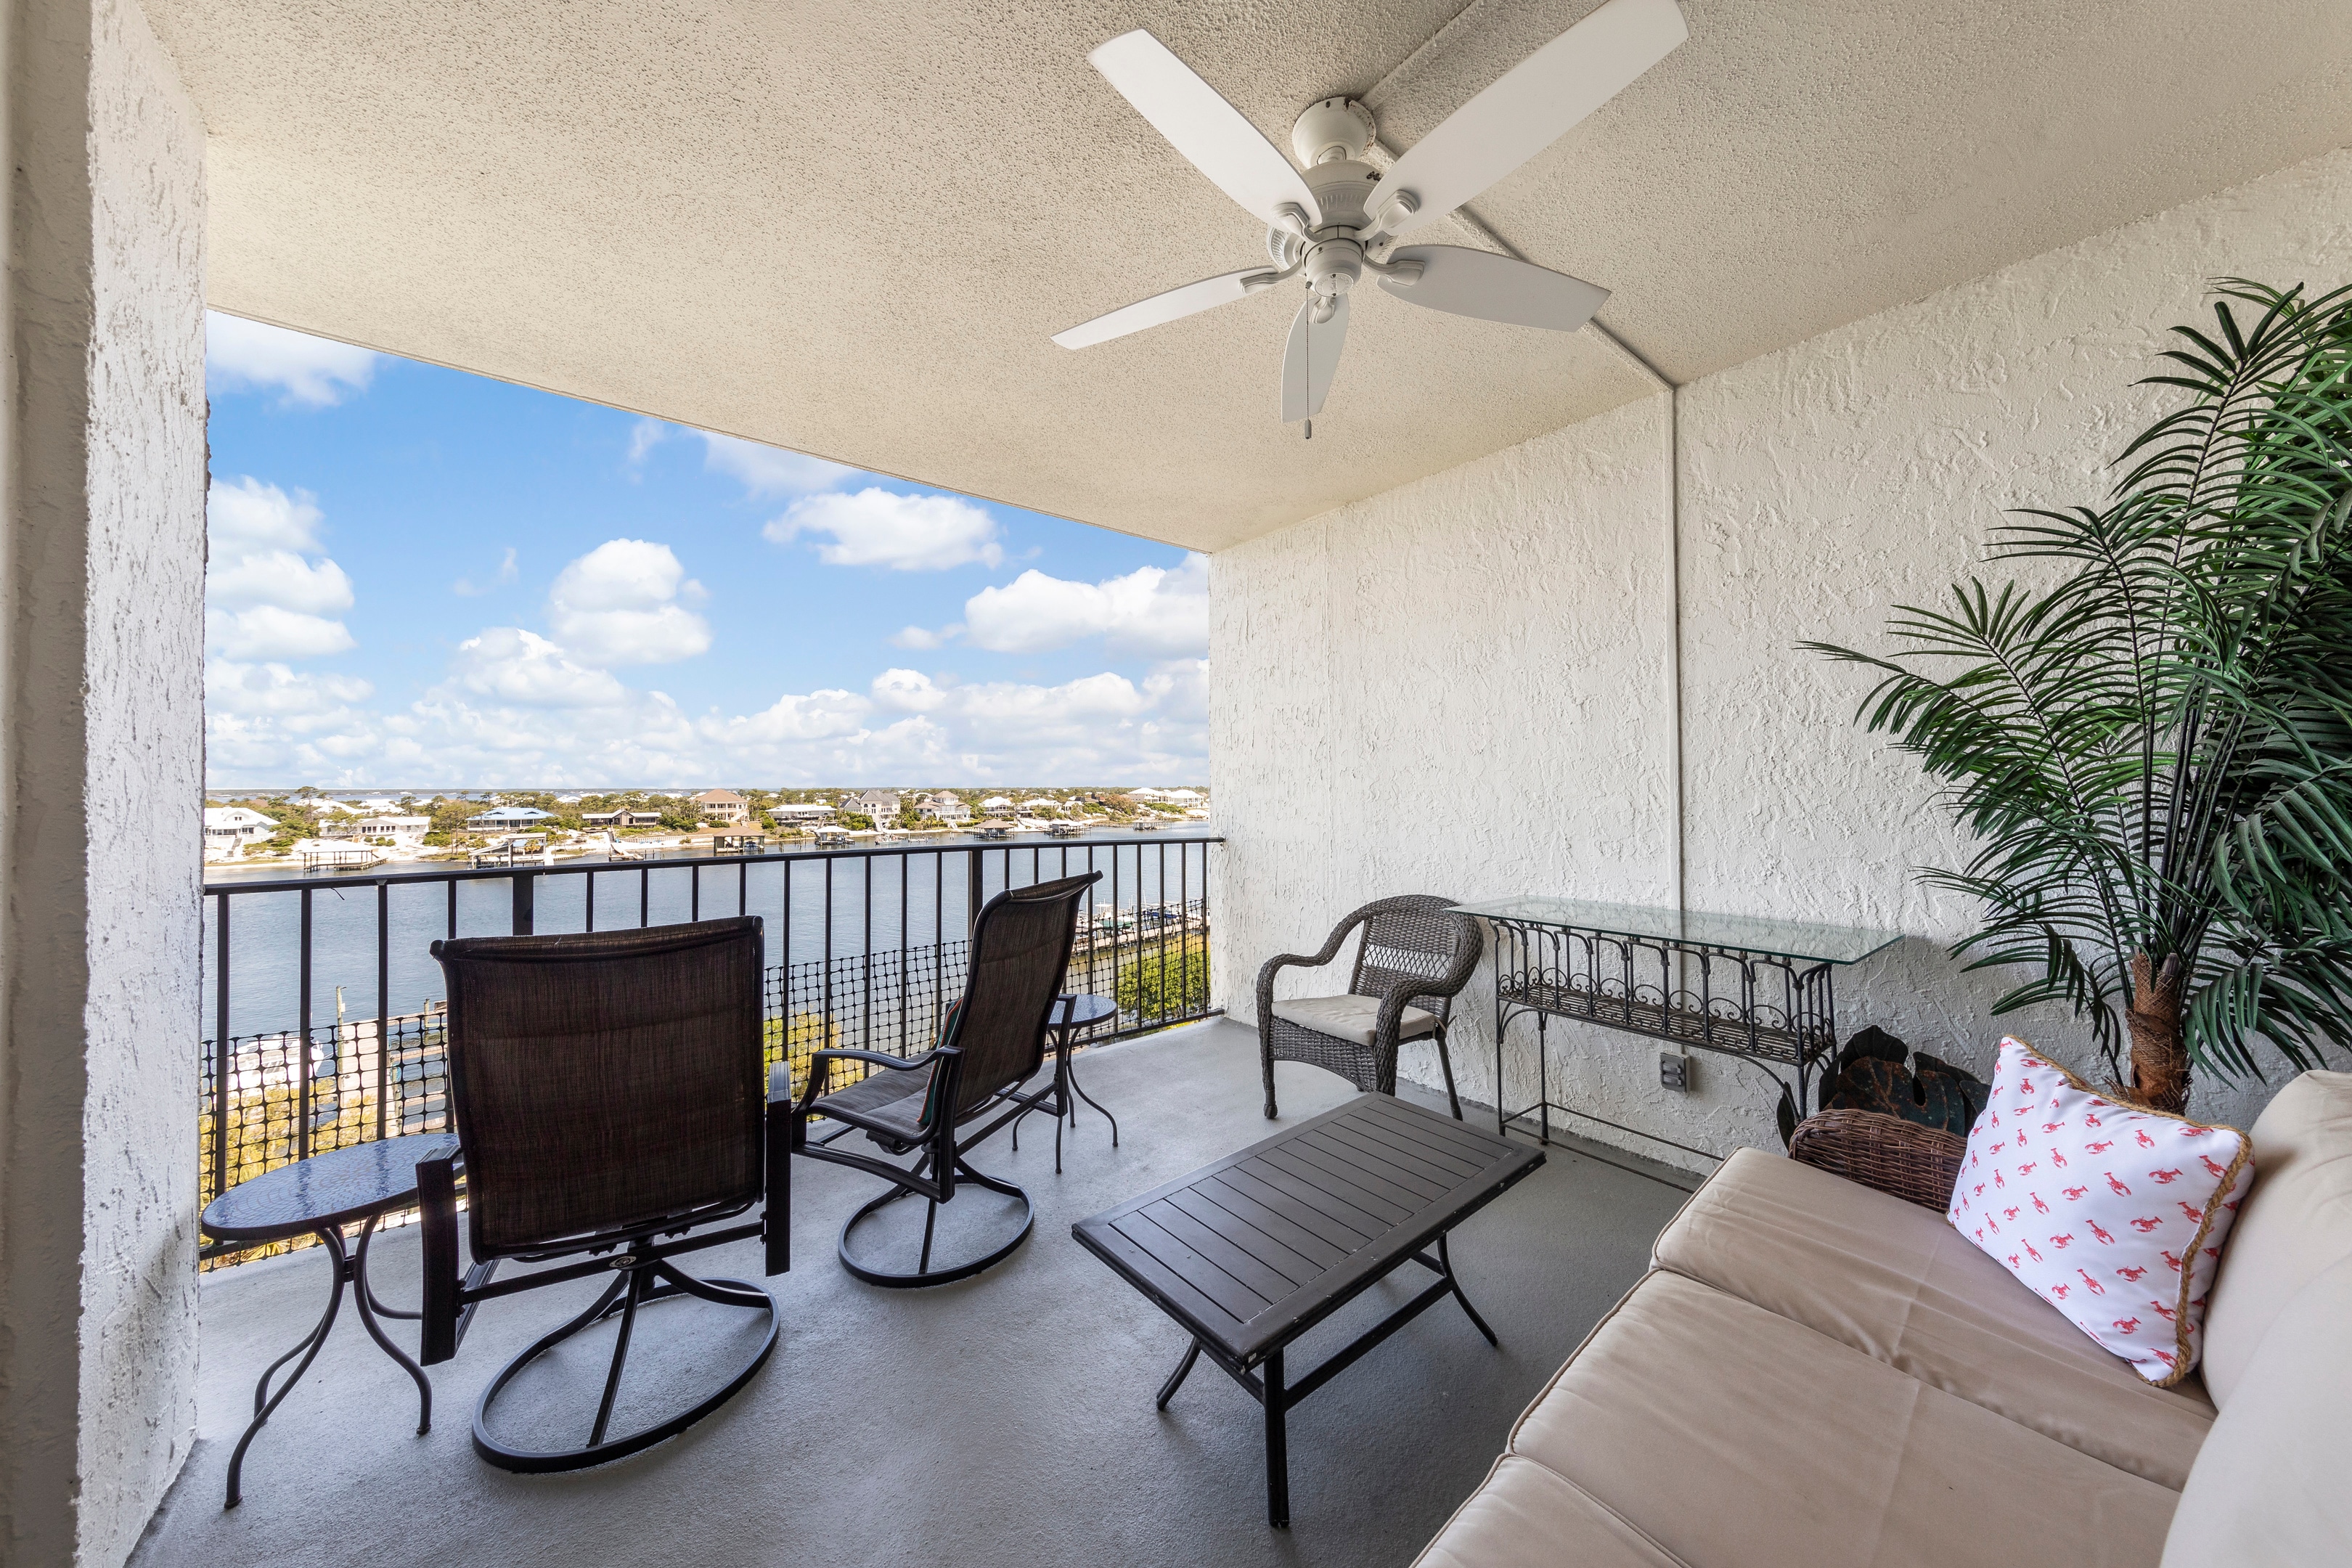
[416,917,791,1471]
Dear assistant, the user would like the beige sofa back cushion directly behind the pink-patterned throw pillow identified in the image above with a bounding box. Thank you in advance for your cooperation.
[2204,1072,2352,1406]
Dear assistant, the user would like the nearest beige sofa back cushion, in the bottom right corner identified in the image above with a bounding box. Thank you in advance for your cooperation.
[2164,1253,2352,1568]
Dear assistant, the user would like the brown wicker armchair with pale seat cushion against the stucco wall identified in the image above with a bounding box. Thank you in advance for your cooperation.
[1258,894,1487,1122]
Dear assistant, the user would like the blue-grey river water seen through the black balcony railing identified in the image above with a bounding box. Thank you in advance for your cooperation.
[203,835,1209,1037]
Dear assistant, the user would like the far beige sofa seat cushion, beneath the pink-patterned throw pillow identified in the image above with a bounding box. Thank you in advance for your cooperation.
[1656,1150,2213,1490]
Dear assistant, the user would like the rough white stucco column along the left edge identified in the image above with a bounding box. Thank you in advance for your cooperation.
[0,0,205,1568]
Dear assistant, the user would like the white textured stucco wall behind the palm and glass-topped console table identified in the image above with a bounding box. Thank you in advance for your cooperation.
[1212,152,2352,1170]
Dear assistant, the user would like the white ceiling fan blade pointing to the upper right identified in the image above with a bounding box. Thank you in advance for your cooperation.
[1376,0,1691,235]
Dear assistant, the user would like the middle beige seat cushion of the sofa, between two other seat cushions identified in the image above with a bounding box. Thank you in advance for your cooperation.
[1510,1270,2176,1568]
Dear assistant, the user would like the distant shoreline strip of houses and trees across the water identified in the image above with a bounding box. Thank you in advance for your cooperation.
[205,785,1209,875]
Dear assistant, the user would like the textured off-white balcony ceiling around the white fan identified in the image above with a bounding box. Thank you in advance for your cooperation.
[146,0,2352,550]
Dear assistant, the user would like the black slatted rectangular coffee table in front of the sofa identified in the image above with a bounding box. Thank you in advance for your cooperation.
[1070,1095,1543,1528]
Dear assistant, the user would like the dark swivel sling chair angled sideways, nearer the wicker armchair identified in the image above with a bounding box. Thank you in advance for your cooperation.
[774,872,1103,1286]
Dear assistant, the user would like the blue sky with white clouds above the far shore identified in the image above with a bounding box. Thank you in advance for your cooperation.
[207,315,1209,788]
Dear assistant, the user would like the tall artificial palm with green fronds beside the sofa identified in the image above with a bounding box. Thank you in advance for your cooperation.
[1806,279,2352,1112]
